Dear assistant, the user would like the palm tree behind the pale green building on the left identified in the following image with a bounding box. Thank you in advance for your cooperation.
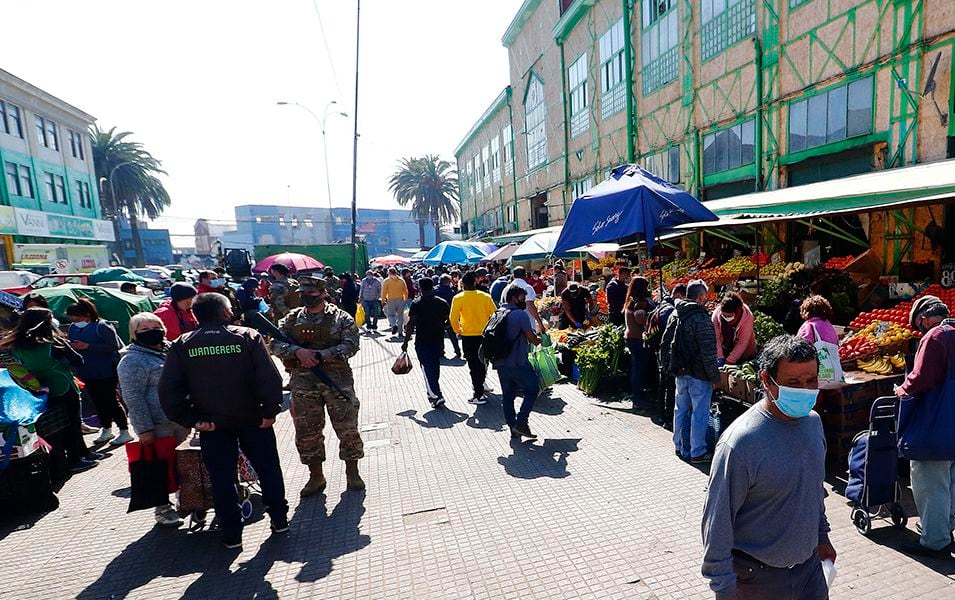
[90,126,171,266]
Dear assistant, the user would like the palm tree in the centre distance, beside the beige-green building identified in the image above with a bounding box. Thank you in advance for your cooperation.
[388,154,458,249]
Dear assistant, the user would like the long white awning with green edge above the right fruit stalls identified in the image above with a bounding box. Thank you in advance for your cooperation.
[679,160,955,229]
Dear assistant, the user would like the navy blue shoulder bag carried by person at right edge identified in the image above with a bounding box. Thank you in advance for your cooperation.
[898,325,955,460]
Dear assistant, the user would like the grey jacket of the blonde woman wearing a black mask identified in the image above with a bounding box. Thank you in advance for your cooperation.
[116,344,178,437]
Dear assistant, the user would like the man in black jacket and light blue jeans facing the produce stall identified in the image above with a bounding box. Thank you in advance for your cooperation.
[660,279,720,464]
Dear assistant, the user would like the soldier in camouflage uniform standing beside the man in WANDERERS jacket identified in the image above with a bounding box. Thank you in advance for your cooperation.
[272,277,365,497]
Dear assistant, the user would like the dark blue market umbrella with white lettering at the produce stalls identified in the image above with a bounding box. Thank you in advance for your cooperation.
[554,165,719,255]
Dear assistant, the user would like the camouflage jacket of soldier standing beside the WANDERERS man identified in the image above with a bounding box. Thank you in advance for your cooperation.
[271,304,358,370]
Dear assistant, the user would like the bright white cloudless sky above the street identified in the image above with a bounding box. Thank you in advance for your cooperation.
[0,0,522,243]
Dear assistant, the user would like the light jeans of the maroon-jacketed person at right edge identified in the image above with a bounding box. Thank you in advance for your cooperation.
[912,460,955,550]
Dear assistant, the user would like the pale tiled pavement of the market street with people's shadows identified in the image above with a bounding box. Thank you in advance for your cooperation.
[0,336,955,600]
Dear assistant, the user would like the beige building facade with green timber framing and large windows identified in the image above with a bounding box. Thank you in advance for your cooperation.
[455,0,955,239]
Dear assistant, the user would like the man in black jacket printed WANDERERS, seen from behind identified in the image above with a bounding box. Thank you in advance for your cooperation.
[159,293,288,549]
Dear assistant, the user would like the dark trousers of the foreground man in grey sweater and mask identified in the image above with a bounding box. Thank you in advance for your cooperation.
[733,552,829,600]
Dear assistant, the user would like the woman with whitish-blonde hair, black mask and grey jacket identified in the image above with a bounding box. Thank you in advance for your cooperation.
[117,312,189,527]
